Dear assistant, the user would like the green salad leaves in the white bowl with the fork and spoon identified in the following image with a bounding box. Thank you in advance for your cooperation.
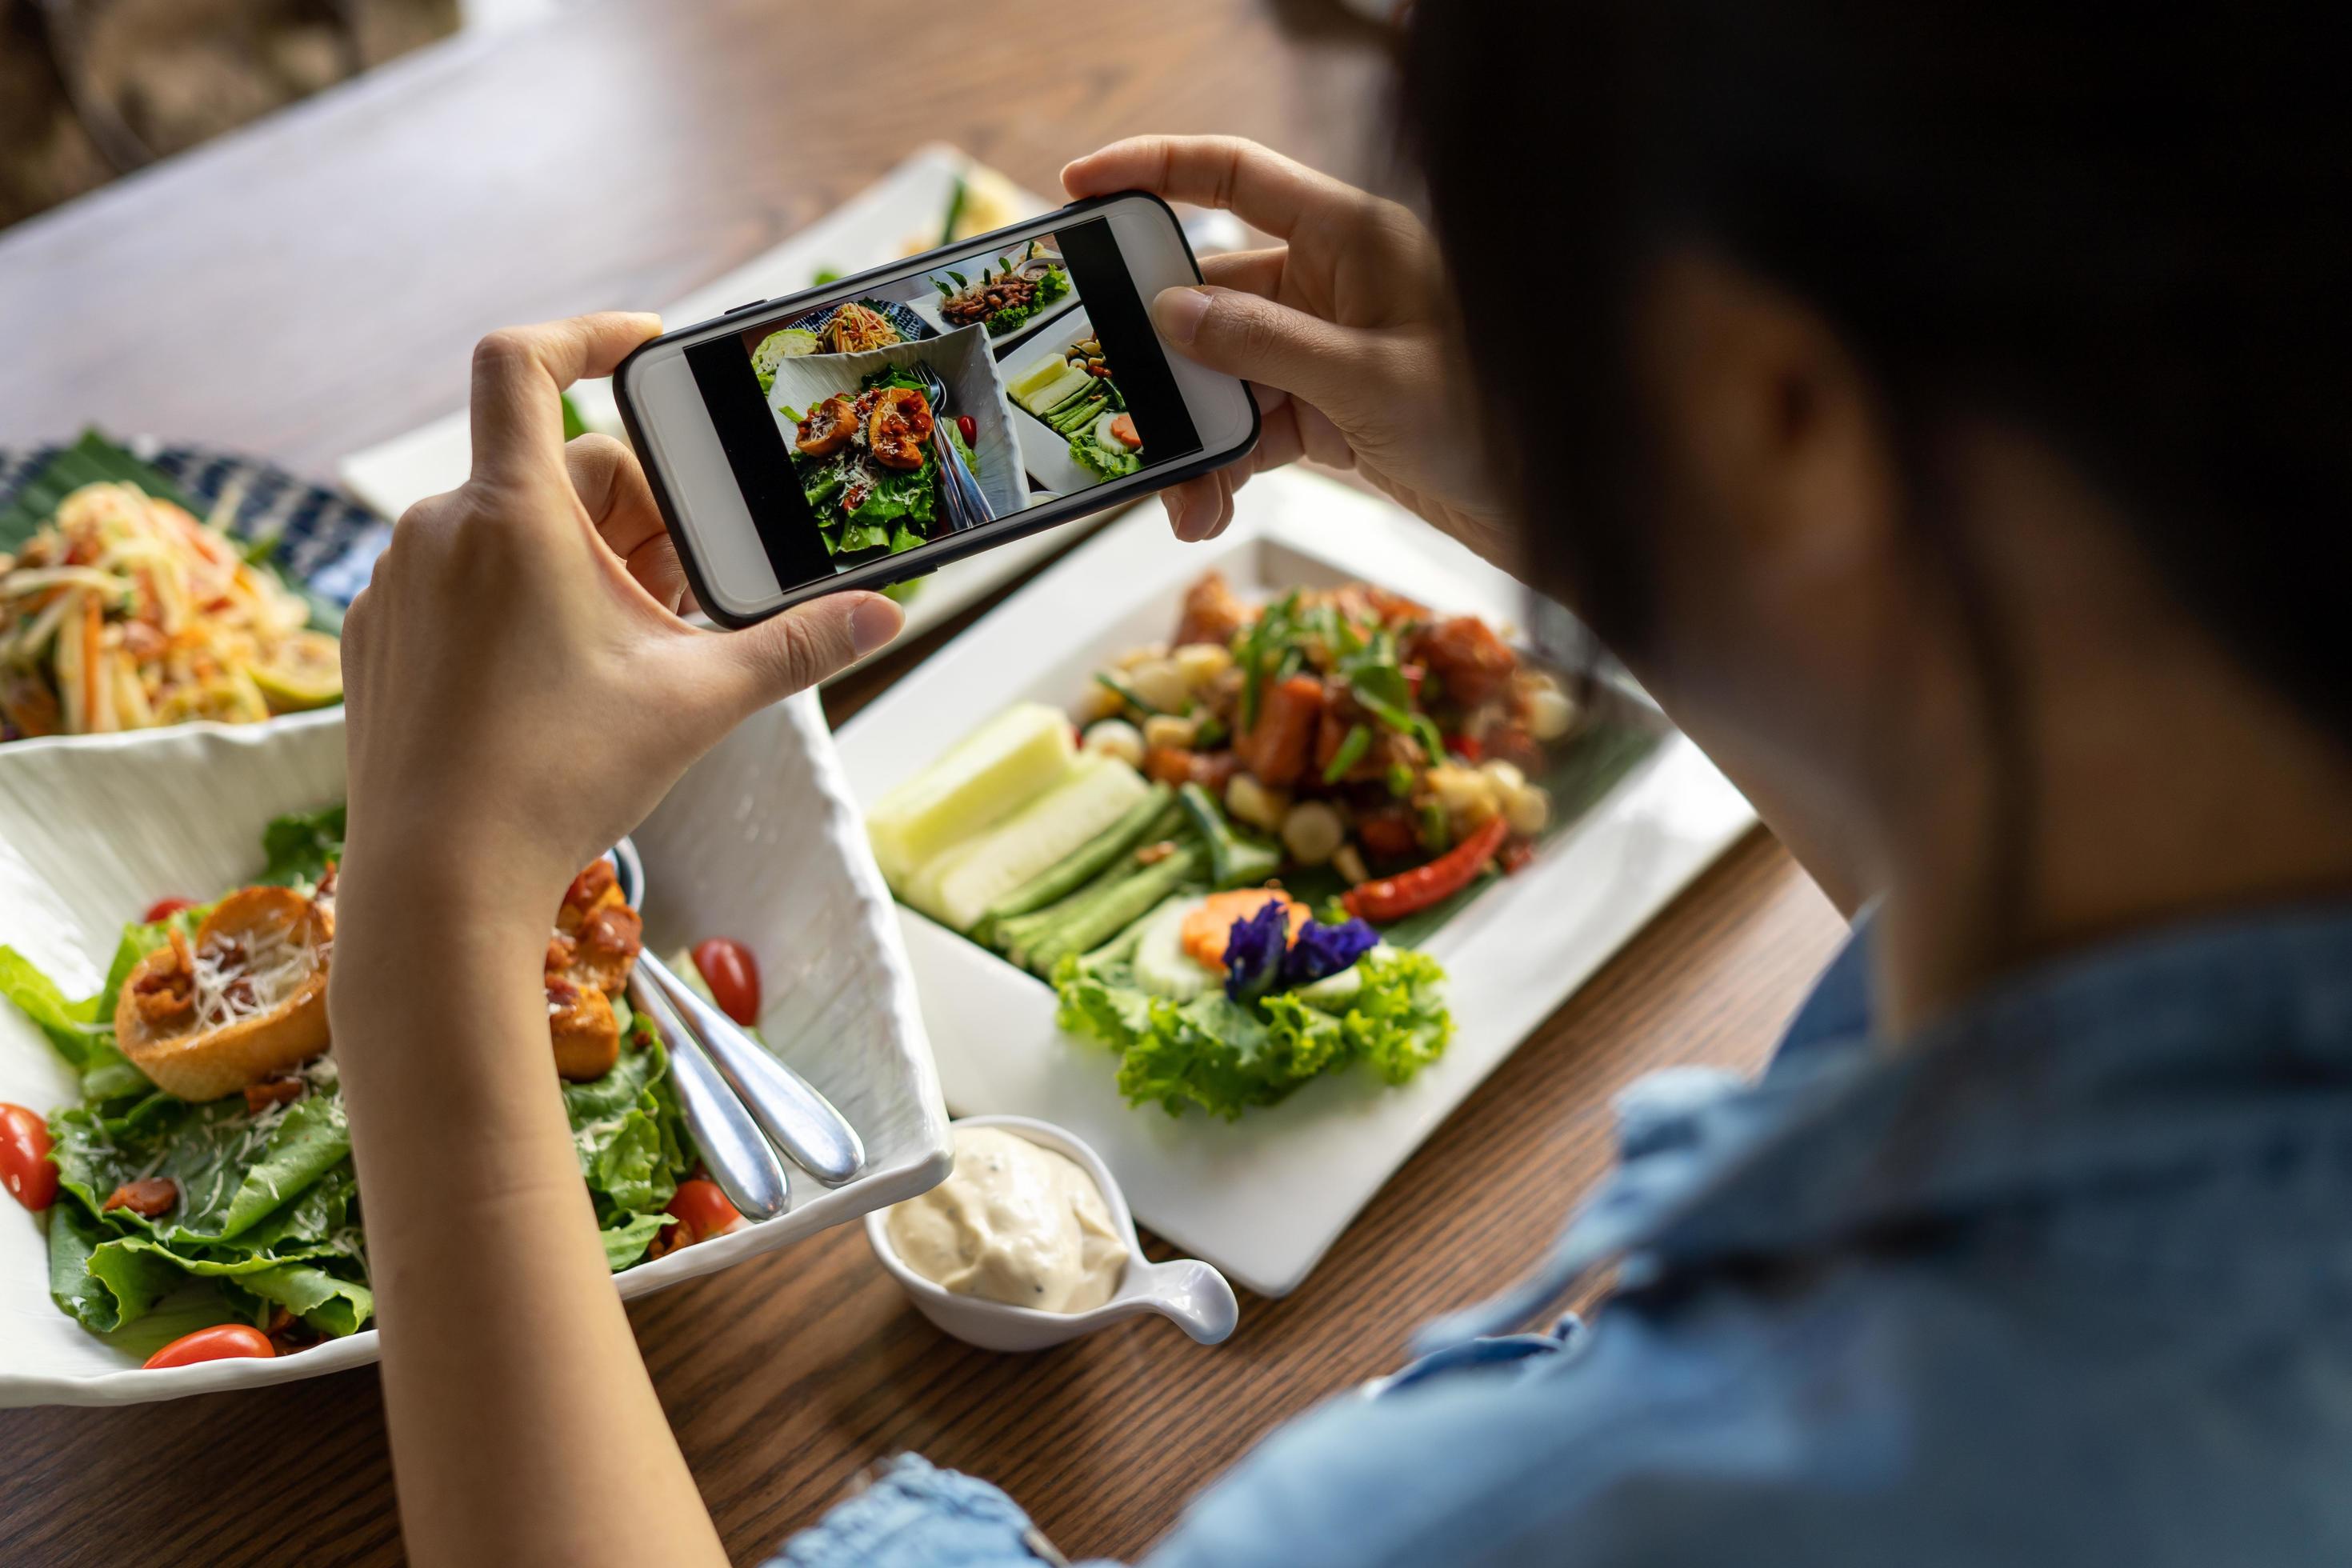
[0,806,694,1350]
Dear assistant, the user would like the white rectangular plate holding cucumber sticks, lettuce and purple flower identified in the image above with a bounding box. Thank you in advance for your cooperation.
[840,470,1754,1295]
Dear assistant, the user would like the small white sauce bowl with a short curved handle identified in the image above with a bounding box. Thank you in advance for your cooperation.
[866,1117,1242,1350]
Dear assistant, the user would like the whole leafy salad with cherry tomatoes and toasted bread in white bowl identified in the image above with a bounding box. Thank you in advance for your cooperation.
[0,806,758,1366]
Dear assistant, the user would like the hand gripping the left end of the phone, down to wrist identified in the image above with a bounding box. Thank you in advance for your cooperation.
[343,313,901,924]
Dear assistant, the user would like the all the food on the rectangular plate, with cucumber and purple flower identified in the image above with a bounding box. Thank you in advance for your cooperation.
[868,571,1654,1119]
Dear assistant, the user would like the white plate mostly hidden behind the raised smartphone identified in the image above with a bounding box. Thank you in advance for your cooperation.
[338,146,1078,679]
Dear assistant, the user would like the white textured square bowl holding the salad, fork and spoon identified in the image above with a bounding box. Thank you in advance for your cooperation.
[0,696,948,1406]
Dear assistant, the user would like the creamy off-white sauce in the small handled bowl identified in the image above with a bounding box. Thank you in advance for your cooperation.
[886,1126,1126,1312]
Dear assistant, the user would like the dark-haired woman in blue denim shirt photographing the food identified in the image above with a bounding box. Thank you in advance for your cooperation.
[332,0,2352,1566]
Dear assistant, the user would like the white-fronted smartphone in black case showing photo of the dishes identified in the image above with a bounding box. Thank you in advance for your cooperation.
[614,190,1258,626]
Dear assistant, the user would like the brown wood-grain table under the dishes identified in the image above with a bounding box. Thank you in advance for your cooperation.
[0,0,1839,1566]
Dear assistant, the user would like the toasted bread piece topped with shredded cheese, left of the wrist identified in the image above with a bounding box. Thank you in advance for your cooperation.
[115,889,334,1100]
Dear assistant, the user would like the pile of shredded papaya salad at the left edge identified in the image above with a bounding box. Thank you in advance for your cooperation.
[0,482,343,741]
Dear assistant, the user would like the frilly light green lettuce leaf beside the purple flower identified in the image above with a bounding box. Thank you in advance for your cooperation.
[1054,947,1454,1122]
